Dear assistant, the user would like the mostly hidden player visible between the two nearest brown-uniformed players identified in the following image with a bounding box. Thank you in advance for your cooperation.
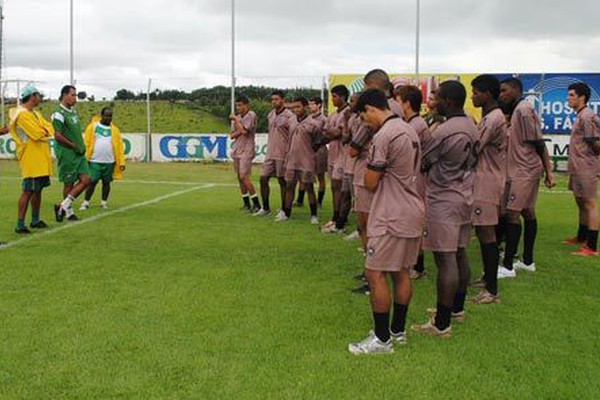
[397,85,431,279]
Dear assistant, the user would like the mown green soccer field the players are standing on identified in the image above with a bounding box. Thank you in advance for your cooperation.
[0,161,600,399]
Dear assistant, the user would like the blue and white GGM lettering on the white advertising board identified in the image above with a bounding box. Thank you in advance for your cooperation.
[160,135,227,160]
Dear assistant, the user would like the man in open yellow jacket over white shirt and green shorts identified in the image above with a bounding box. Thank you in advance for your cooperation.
[79,107,125,210]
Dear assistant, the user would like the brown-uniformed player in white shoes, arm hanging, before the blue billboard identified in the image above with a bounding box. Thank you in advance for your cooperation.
[498,78,555,279]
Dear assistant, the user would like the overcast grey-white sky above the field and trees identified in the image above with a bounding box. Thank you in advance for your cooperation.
[2,0,600,97]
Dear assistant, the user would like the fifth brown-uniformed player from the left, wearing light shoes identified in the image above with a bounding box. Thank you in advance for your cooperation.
[322,85,350,233]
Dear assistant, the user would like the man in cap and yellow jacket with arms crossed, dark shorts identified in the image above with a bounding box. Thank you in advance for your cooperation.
[9,86,54,234]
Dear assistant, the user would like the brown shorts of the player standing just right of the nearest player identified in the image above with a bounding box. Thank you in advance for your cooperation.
[423,222,471,252]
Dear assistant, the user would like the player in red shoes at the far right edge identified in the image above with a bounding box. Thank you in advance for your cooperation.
[565,82,600,256]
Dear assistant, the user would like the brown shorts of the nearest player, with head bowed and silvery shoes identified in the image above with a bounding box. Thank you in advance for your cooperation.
[365,235,421,272]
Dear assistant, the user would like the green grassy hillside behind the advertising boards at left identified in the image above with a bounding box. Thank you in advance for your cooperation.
[7,101,229,133]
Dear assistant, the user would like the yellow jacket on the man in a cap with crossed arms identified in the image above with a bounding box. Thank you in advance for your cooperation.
[9,106,54,178]
